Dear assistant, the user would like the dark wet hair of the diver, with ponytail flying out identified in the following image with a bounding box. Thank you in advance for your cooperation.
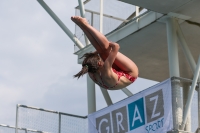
[74,53,100,79]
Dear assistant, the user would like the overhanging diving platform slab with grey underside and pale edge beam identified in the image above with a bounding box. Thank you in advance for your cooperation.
[75,0,200,82]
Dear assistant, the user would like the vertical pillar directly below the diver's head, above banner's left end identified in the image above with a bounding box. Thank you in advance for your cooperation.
[87,74,96,114]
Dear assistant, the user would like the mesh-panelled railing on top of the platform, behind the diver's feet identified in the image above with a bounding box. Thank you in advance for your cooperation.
[74,0,147,52]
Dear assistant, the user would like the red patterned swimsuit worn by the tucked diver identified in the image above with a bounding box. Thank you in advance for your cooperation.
[93,68,137,89]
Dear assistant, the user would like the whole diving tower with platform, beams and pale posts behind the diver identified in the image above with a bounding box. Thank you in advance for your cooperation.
[37,0,200,133]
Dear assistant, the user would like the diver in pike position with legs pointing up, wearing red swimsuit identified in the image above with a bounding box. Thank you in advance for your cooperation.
[71,16,138,90]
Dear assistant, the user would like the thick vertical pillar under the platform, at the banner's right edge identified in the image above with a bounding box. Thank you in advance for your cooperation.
[165,17,183,130]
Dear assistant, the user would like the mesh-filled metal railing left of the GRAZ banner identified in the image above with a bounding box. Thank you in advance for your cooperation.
[15,105,88,133]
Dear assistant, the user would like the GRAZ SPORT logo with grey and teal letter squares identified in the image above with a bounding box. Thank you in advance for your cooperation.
[96,89,165,133]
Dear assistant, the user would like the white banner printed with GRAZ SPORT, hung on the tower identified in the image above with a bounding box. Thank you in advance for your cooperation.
[88,79,173,133]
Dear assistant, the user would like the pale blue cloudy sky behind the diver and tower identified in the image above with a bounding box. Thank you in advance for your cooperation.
[0,0,157,125]
